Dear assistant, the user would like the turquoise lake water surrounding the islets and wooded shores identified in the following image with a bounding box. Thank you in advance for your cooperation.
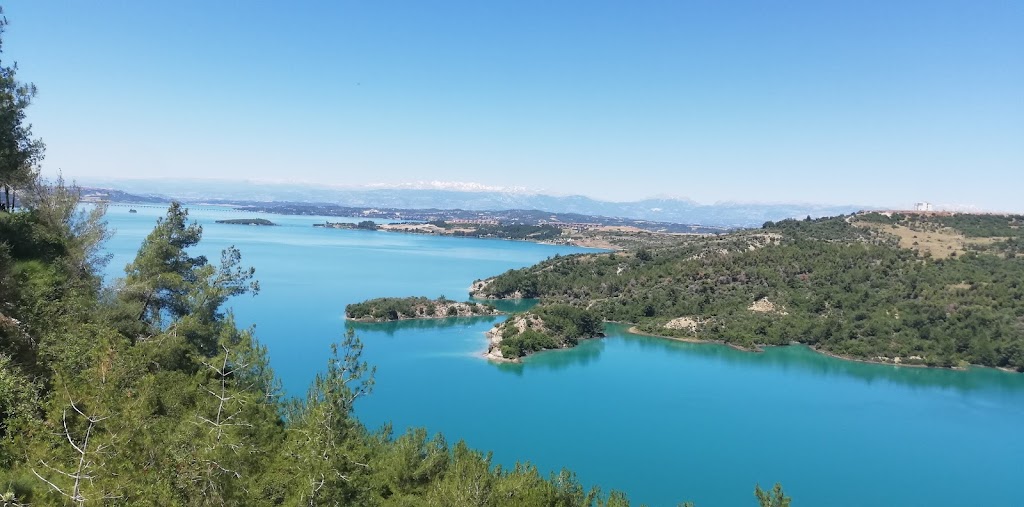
[101,207,1024,507]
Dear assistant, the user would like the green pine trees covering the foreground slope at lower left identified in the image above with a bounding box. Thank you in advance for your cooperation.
[0,193,663,506]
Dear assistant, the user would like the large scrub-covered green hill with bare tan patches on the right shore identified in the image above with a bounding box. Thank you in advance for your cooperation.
[473,213,1024,371]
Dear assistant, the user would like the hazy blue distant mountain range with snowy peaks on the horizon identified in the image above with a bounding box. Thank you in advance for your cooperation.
[80,179,865,226]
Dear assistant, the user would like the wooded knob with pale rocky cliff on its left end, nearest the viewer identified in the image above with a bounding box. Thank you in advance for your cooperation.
[484,304,604,362]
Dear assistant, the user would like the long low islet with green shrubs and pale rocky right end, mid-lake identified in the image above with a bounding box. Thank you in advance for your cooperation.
[345,296,503,323]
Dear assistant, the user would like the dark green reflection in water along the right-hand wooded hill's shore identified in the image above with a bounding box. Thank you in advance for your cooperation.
[607,324,1024,392]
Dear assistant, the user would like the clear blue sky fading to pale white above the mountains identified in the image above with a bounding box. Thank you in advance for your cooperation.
[0,0,1024,212]
